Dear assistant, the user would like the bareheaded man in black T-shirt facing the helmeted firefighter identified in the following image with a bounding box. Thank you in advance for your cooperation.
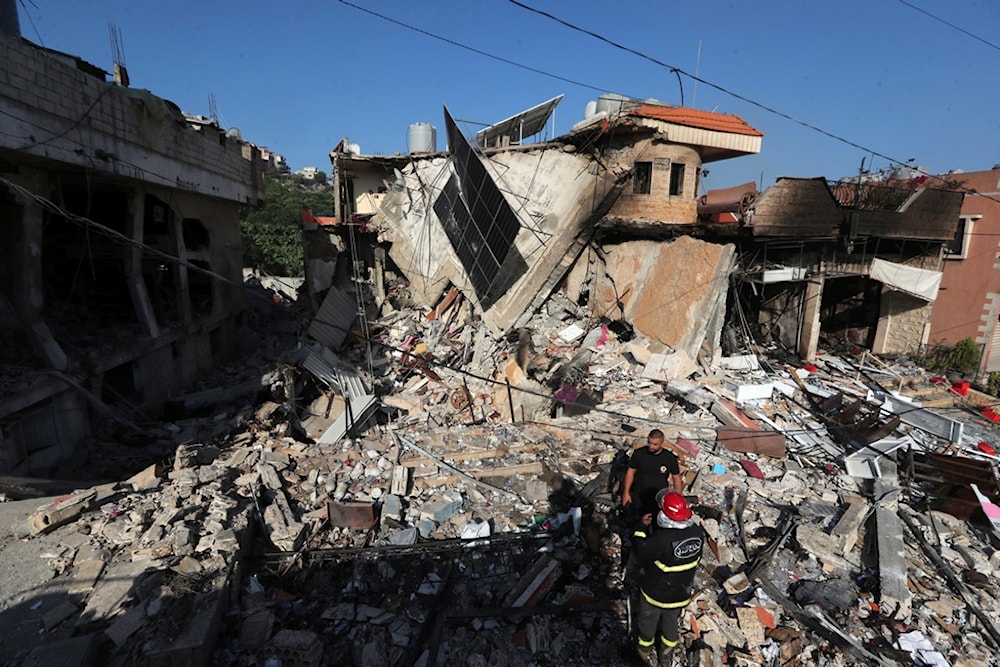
[622,428,684,526]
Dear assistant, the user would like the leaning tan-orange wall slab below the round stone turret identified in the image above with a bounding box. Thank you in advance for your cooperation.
[590,236,736,359]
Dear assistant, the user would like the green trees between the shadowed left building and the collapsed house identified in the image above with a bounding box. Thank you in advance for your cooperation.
[240,175,334,276]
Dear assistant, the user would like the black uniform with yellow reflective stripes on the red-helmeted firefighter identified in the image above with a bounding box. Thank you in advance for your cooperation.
[636,515,705,649]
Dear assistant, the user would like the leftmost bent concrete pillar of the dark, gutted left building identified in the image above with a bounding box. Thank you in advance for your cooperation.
[10,167,69,371]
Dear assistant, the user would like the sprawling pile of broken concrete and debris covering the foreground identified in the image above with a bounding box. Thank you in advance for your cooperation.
[5,278,1000,666]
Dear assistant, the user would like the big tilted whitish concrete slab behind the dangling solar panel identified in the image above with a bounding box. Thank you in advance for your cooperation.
[378,147,614,331]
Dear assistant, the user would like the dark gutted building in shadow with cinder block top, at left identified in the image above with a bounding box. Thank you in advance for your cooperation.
[0,18,263,475]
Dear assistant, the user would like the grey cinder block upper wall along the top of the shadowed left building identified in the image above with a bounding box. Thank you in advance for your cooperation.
[0,34,262,202]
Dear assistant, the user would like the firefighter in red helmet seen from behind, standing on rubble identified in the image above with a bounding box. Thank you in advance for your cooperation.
[633,490,705,667]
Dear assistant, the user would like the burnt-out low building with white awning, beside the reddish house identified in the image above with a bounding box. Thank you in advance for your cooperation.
[736,172,963,359]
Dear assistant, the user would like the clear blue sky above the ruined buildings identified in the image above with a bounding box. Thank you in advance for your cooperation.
[18,0,1000,188]
